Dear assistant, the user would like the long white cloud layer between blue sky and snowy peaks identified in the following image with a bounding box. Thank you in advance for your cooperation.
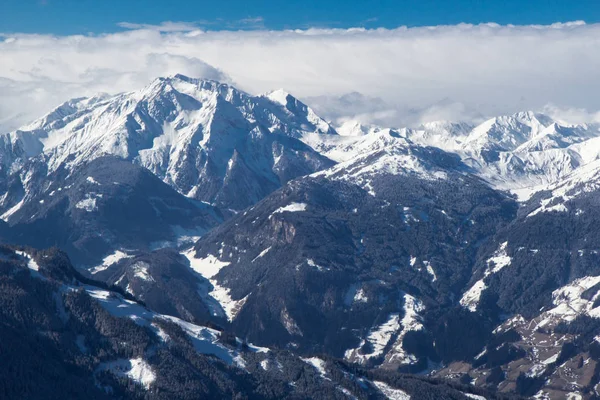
[0,22,600,130]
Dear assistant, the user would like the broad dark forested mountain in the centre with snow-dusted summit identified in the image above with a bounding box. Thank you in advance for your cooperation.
[186,138,516,370]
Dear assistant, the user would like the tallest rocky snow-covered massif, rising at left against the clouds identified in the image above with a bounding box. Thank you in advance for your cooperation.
[0,75,335,209]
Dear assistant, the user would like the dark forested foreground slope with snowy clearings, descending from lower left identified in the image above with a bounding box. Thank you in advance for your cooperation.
[0,246,516,400]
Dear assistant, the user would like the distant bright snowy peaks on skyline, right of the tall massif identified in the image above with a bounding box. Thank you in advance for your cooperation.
[318,112,600,200]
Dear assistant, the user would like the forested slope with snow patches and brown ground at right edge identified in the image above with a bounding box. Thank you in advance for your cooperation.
[436,162,600,399]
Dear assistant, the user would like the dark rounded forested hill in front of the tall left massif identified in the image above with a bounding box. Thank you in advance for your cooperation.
[2,157,223,266]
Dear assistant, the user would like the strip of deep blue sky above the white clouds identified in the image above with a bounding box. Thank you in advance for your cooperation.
[0,0,600,35]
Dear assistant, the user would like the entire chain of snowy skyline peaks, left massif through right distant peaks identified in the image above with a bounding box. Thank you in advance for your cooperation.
[5,75,600,217]
